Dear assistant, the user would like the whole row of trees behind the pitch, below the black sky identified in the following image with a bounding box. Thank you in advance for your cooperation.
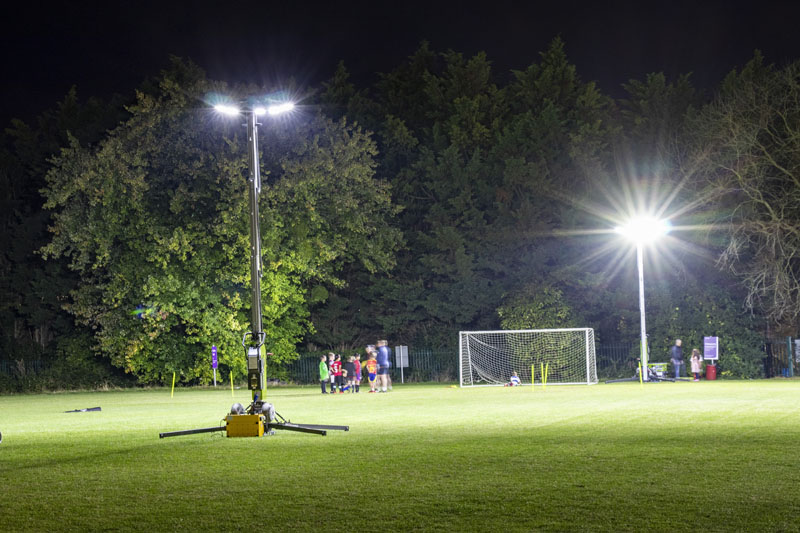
[0,40,800,390]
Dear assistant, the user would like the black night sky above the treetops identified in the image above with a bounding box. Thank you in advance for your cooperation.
[0,0,800,125]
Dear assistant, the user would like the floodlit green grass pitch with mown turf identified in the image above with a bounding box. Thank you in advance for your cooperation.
[0,380,800,531]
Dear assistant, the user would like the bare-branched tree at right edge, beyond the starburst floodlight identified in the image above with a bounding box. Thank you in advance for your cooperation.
[685,53,800,330]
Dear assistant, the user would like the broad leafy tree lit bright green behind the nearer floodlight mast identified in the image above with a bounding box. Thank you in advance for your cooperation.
[45,60,396,382]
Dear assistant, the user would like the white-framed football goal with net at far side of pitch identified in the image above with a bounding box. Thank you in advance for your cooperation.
[458,328,597,387]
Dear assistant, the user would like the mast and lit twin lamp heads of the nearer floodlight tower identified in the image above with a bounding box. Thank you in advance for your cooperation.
[214,102,294,400]
